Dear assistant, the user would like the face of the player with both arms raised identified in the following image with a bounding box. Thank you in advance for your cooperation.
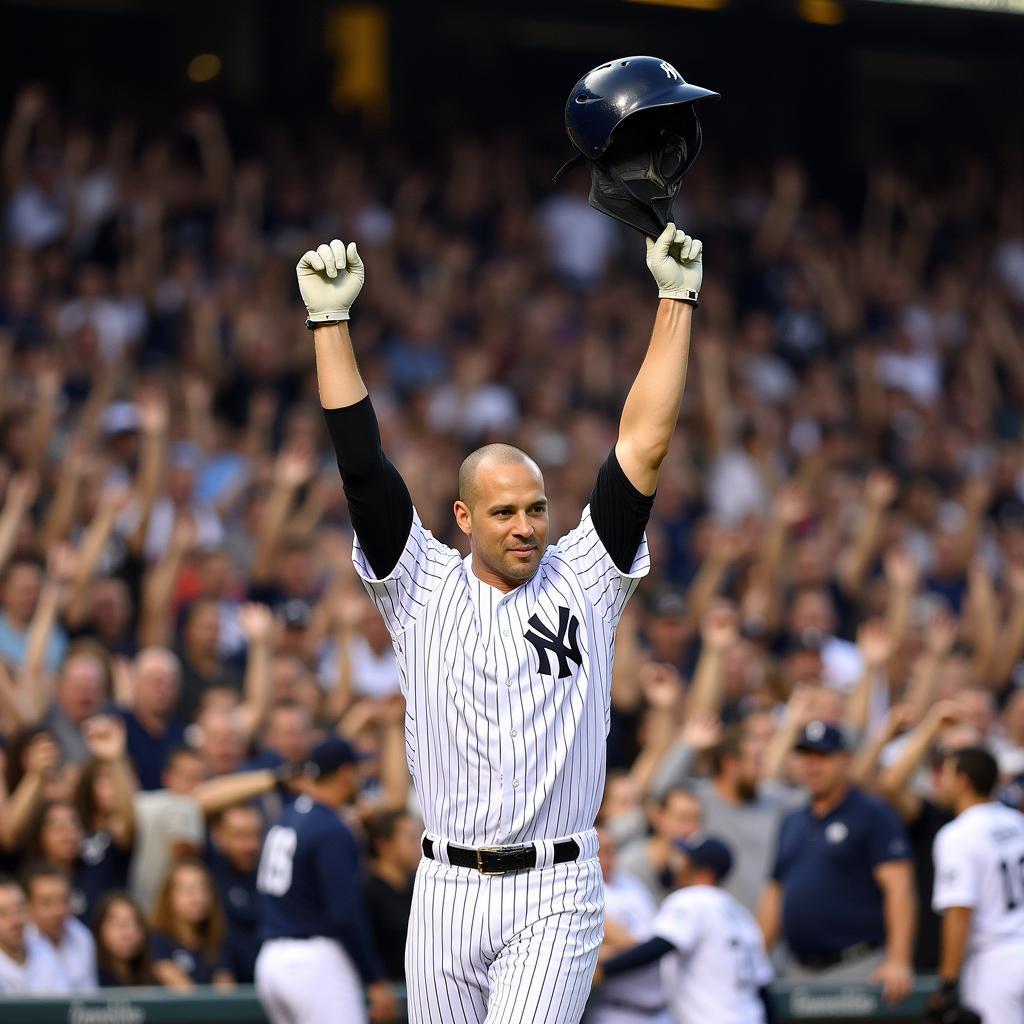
[456,463,548,588]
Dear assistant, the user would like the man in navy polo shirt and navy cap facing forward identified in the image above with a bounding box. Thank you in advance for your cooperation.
[758,721,916,1002]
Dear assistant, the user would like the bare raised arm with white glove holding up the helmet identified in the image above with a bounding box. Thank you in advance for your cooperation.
[615,224,702,495]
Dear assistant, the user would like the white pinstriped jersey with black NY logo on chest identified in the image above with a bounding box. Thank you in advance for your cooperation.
[353,505,650,846]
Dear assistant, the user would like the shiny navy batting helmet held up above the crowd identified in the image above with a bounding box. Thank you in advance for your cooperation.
[555,56,718,237]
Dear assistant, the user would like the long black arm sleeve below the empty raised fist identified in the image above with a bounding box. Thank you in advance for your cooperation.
[324,395,413,579]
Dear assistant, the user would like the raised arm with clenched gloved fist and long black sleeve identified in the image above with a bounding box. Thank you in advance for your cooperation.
[295,239,413,579]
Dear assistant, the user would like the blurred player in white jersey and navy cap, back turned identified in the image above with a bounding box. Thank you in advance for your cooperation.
[595,836,772,1024]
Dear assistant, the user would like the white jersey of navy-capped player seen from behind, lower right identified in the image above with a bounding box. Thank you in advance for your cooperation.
[653,886,773,1024]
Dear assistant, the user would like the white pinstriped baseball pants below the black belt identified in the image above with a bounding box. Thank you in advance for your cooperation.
[406,833,604,1024]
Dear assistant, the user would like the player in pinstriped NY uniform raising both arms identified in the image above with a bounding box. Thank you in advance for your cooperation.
[296,224,701,1024]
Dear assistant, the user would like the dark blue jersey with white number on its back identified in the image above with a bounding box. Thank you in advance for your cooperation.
[256,797,383,984]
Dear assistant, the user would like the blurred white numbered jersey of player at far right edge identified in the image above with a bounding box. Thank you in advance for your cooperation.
[932,803,1024,954]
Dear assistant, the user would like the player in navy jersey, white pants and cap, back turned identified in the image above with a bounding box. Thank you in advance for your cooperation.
[256,737,395,1024]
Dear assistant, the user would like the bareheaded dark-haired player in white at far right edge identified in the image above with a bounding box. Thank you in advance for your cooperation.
[929,746,1024,1024]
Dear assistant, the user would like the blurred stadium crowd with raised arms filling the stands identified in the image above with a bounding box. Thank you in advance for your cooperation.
[0,87,1024,1011]
